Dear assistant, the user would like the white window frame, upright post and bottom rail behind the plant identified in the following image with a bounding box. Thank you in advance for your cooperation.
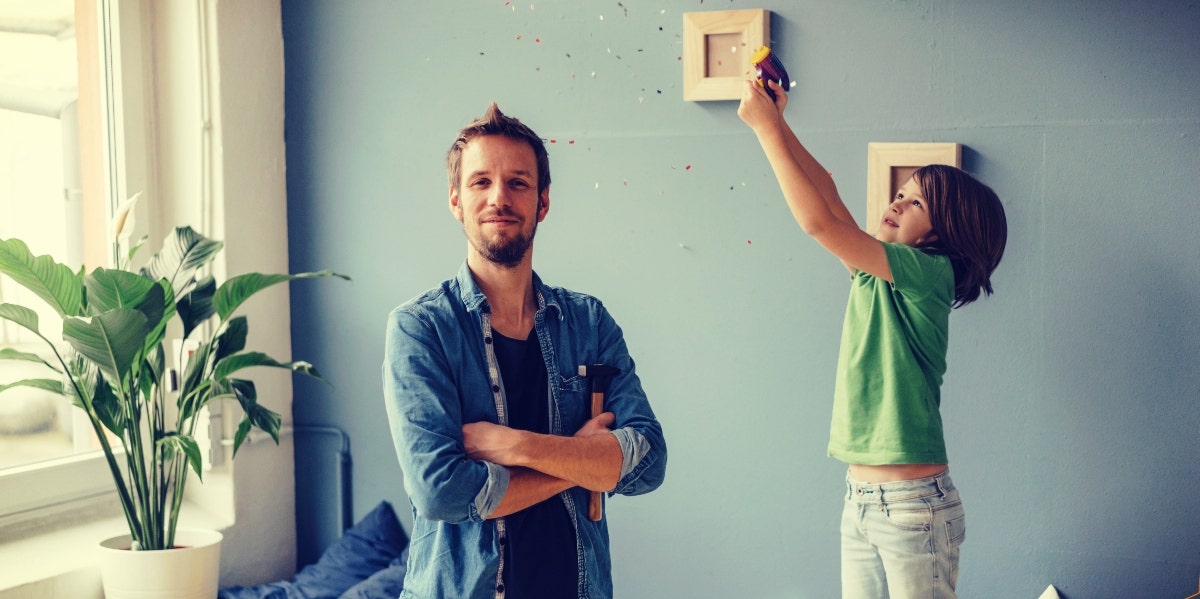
[0,0,157,538]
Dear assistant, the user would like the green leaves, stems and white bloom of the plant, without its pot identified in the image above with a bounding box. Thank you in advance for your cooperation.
[0,197,349,597]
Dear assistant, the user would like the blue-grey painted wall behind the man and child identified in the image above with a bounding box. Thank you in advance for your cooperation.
[276,0,1200,599]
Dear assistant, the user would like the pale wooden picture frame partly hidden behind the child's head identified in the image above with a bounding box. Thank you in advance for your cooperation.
[866,142,962,235]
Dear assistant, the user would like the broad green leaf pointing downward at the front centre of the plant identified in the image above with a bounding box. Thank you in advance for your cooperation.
[62,309,150,389]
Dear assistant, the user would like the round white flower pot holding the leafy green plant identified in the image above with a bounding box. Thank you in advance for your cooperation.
[100,528,221,599]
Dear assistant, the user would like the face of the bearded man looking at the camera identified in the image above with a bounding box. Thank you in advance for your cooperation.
[450,136,550,268]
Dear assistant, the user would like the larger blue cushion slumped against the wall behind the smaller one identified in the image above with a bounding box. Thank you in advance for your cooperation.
[217,502,408,599]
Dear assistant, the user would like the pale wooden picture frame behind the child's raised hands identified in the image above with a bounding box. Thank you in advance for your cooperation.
[683,8,770,102]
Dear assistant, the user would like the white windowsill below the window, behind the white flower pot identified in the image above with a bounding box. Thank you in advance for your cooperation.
[0,501,233,599]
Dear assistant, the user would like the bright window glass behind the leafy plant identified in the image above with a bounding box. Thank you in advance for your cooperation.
[0,0,152,523]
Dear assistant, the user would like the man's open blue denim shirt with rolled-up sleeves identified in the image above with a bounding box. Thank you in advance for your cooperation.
[383,264,667,599]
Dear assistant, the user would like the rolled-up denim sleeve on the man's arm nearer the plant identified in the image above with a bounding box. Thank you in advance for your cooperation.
[383,303,509,522]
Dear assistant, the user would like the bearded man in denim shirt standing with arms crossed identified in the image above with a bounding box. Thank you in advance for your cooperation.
[384,103,667,599]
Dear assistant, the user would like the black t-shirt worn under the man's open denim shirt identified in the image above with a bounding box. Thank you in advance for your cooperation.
[492,330,580,599]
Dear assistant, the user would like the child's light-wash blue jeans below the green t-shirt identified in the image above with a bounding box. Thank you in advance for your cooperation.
[841,472,966,599]
